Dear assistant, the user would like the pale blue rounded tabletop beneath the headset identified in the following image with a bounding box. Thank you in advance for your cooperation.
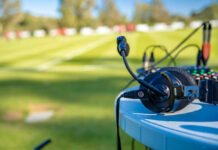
[119,94,218,150]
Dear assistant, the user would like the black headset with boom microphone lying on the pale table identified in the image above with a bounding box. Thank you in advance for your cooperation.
[117,36,199,113]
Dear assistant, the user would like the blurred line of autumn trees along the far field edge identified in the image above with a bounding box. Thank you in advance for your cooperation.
[0,0,218,33]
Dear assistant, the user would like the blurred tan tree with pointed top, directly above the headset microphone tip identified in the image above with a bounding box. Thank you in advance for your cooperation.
[99,0,126,27]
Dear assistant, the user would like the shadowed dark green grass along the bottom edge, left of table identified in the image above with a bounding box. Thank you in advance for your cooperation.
[0,115,135,150]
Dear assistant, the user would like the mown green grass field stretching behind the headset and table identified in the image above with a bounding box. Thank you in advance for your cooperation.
[0,29,218,150]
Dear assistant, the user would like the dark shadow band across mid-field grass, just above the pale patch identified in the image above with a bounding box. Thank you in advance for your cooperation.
[0,77,129,106]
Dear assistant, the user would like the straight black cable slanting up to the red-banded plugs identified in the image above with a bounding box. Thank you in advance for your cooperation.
[154,23,204,66]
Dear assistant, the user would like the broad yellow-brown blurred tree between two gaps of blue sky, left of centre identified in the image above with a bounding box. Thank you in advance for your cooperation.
[60,0,95,29]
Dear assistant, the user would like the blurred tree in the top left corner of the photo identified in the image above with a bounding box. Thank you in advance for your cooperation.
[0,0,22,31]
